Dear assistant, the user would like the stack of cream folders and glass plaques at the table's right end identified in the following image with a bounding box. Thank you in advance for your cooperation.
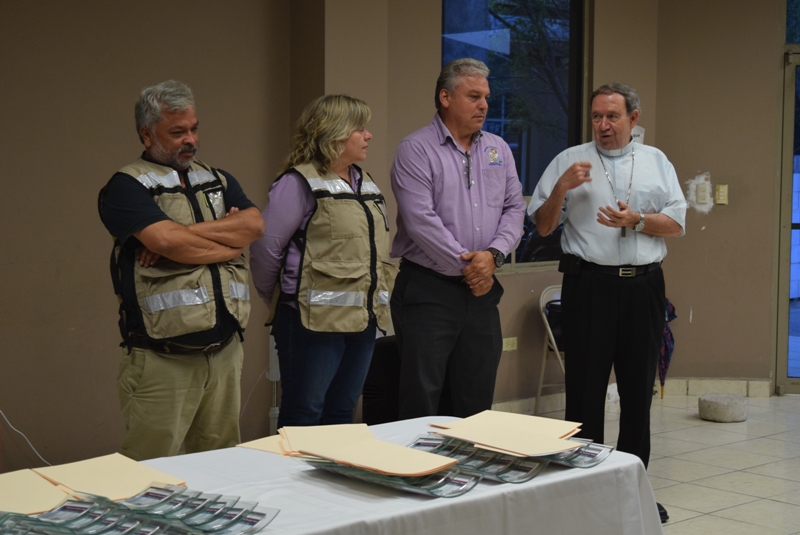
[424,411,614,472]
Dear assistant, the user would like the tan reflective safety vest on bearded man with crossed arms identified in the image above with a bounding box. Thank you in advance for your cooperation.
[115,159,250,339]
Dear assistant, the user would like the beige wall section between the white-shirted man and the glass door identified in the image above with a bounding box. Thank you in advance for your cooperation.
[657,0,786,378]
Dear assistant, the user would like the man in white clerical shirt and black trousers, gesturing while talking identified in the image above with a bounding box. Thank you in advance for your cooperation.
[528,84,686,522]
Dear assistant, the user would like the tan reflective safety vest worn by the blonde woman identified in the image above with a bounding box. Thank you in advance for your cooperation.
[294,164,397,332]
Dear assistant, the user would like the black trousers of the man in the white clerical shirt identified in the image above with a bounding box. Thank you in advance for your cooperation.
[561,268,666,466]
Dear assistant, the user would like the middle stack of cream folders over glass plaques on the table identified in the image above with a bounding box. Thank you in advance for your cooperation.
[240,424,481,498]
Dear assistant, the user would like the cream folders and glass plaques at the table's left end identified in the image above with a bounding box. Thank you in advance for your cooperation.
[0,454,279,535]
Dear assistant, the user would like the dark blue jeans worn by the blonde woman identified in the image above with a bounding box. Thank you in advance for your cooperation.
[272,304,375,428]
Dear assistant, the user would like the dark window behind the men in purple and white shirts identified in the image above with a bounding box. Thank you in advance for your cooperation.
[442,0,584,263]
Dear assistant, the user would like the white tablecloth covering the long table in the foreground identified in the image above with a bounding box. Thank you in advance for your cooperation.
[144,417,662,535]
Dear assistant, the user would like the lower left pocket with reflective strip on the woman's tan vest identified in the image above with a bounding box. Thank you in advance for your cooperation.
[298,260,369,332]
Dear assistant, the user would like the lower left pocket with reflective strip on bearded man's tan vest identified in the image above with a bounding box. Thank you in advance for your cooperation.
[134,259,217,339]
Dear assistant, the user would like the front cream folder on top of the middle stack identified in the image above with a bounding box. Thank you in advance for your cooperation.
[301,439,457,476]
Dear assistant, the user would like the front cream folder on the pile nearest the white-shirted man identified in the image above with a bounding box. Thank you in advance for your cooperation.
[437,426,581,457]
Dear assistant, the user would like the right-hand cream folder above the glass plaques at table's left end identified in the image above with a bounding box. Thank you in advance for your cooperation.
[33,453,184,500]
